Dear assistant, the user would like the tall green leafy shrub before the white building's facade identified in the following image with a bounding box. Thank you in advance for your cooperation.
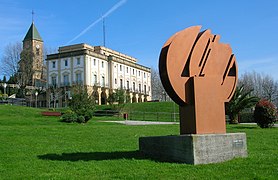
[69,86,95,122]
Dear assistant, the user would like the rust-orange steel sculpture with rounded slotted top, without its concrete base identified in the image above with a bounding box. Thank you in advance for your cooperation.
[159,26,238,134]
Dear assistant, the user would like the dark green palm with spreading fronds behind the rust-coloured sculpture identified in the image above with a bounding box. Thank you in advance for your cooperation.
[226,86,259,124]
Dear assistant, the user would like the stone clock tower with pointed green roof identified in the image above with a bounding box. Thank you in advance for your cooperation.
[23,22,43,86]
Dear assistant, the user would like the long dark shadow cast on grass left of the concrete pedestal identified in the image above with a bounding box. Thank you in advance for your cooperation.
[38,151,146,161]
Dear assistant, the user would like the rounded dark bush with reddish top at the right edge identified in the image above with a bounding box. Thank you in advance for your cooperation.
[254,99,277,128]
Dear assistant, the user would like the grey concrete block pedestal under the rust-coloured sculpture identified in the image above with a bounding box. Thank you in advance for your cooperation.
[139,133,247,164]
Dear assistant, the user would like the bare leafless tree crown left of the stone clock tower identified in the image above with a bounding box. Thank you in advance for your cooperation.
[1,42,22,76]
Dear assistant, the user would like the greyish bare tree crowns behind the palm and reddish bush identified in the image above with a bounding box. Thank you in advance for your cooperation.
[239,71,278,105]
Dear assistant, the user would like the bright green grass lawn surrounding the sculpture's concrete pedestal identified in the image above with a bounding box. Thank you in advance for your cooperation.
[0,106,278,179]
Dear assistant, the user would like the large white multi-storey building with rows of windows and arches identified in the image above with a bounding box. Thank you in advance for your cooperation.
[46,44,151,106]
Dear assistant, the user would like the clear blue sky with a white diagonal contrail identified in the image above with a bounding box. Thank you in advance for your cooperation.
[0,0,278,80]
